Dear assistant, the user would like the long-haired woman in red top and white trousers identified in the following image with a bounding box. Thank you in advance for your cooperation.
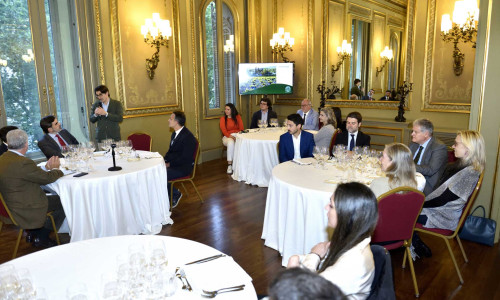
[219,103,245,174]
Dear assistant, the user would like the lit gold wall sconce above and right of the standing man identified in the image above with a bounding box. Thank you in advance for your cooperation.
[141,13,172,80]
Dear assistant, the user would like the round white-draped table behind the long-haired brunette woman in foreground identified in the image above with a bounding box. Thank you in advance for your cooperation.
[261,158,380,266]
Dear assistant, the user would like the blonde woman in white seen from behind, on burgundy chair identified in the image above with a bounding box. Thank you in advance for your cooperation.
[370,143,425,197]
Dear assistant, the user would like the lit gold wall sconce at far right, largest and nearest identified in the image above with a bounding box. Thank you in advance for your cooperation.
[441,0,479,76]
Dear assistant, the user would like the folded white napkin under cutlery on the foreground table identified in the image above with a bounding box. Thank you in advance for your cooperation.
[183,256,252,291]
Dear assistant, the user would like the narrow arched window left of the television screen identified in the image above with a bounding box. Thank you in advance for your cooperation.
[203,0,236,116]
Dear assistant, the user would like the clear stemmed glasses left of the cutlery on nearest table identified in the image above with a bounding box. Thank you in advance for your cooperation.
[101,241,180,299]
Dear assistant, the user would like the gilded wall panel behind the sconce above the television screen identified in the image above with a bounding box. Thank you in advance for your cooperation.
[274,0,316,105]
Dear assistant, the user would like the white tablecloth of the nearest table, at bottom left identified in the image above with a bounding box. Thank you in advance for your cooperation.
[5,236,257,300]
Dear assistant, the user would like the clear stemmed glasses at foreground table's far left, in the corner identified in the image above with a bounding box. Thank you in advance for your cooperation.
[0,265,47,300]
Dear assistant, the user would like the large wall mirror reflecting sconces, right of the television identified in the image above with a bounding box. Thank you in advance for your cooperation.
[323,0,414,109]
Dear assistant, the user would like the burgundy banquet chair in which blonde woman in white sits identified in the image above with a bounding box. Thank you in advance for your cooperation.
[372,187,425,297]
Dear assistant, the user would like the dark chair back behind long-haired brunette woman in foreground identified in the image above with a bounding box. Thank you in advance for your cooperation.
[366,245,396,300]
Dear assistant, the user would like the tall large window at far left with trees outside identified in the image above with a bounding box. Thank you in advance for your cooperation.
[0,0,88,156]
